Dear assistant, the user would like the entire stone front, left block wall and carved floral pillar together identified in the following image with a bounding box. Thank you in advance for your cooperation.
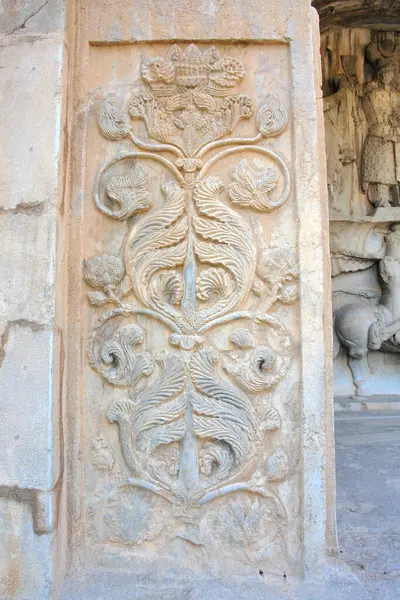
[0,0,340,600]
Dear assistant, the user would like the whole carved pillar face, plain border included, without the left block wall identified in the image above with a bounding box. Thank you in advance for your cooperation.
[62,2,335,597]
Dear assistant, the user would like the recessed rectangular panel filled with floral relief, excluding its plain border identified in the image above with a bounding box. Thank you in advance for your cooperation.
[82,43,301,575]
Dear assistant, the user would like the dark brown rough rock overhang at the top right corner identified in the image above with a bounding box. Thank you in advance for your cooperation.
[312,0,400,33]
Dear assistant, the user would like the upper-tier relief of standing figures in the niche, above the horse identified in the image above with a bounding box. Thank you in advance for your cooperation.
[324,39,400,214]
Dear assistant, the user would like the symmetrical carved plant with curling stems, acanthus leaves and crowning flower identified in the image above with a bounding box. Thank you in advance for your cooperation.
[84,45,297,513]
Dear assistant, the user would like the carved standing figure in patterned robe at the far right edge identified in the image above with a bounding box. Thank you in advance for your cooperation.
[359,40,400,207]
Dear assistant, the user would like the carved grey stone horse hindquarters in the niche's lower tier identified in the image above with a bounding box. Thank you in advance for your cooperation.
[333,254,400,396]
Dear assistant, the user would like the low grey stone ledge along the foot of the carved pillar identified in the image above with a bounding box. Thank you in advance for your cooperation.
[56,561,370,600]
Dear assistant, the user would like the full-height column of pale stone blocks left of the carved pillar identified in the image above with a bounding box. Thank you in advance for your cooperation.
[0,0,67,600]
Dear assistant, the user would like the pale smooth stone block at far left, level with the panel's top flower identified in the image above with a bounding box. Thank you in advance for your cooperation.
[0,34,63,212]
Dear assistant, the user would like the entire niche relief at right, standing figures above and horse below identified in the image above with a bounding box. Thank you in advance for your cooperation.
[324,30,400,396]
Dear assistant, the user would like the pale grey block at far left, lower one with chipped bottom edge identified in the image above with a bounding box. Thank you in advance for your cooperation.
[0,324,58,489]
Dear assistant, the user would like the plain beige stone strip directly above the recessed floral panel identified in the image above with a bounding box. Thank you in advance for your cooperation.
[85,0,298,43]
